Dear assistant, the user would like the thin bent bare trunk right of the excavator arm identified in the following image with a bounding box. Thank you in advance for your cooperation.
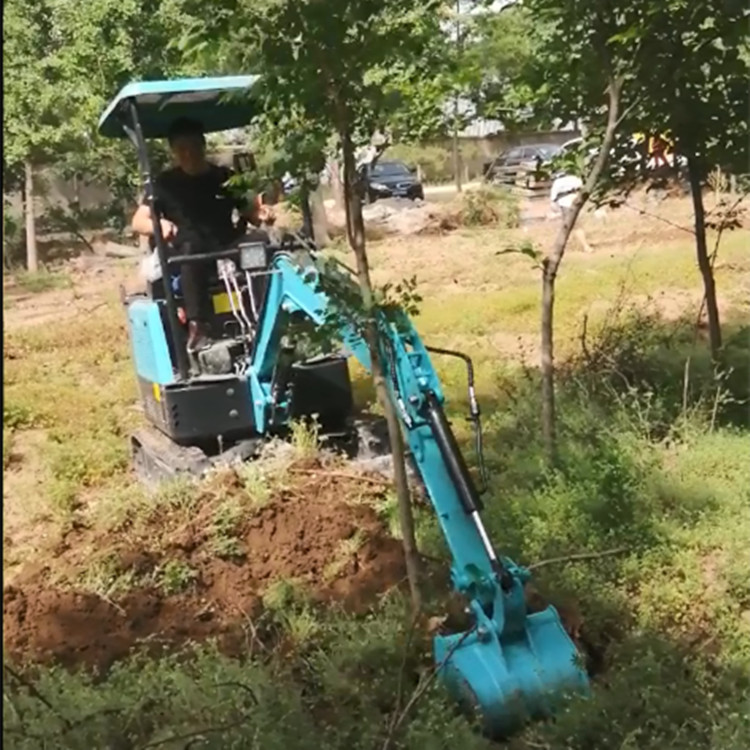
[541,78,622,466]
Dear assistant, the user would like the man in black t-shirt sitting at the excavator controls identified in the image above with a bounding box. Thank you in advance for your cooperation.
[132,118,272,352]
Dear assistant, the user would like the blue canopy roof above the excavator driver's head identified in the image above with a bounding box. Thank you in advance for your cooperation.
[99,75,260,138]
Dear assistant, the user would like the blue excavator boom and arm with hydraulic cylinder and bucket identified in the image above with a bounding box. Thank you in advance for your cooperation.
[249,253,588,735]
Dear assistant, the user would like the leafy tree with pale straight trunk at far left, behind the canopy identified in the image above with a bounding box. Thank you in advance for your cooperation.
[3,0,197,270]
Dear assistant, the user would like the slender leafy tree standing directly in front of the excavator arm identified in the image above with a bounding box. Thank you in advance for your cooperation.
[182,0,452,608]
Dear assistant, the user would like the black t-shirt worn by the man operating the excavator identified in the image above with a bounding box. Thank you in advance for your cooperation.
[147,164,247,253]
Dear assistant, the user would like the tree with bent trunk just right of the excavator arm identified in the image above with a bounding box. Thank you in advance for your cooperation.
[484,0,630,465]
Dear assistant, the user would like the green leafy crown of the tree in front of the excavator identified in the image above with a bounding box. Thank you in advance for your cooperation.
[181,0,456,184]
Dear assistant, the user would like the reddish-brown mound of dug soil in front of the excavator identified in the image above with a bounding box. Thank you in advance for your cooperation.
[3,467,404,670]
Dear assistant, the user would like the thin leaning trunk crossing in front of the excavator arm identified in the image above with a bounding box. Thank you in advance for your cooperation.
[341,132,422,614]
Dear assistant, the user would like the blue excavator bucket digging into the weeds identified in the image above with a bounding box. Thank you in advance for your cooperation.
[434,592,588,738]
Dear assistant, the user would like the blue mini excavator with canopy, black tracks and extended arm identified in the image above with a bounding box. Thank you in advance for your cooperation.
[99,76,589,737]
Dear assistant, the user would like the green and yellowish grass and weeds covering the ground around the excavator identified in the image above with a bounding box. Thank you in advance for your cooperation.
[4,200,750,750]
